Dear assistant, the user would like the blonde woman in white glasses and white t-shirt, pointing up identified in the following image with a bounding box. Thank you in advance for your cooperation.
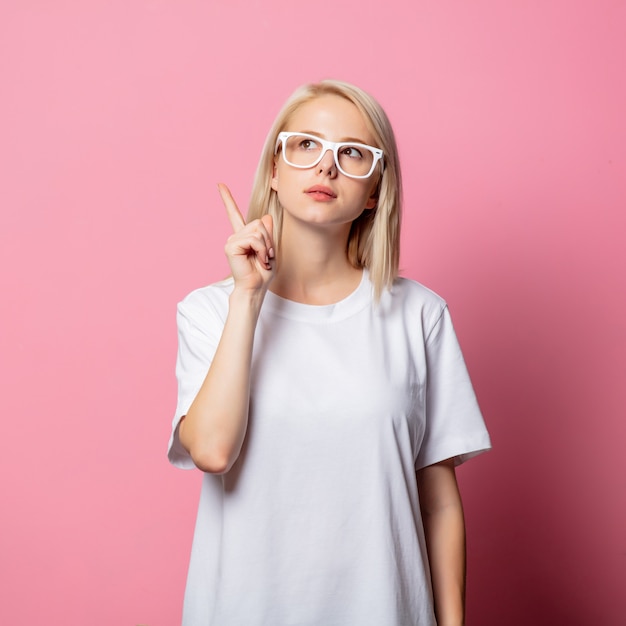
[169,81,490,626]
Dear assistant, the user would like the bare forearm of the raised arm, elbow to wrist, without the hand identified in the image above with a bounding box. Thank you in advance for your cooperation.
[179,290,264,473]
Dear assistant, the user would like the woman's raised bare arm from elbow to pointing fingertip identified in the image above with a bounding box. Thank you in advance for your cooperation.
[178,185,274,474]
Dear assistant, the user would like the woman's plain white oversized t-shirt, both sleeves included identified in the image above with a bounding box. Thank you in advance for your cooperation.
[168,271,490,626]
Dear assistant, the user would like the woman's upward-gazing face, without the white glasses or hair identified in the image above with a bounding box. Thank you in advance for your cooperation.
[272,95,380,233]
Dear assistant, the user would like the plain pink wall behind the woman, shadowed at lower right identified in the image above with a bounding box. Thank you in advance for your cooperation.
[0,0,626,626]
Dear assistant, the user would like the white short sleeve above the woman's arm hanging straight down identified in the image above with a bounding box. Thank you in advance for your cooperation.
[415,306,491,469]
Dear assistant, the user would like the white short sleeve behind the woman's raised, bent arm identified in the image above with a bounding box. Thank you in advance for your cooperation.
[167,292,224,469]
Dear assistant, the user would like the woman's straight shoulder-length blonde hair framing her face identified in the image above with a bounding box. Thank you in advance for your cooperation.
[248,80,402,300]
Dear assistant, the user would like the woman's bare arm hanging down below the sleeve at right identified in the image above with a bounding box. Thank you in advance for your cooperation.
[417,459,465,626]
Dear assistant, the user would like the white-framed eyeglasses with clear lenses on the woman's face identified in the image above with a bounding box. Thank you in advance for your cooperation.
[274,132,384,178]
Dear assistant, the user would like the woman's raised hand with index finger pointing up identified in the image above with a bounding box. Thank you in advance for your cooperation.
[217,183,275,292]
